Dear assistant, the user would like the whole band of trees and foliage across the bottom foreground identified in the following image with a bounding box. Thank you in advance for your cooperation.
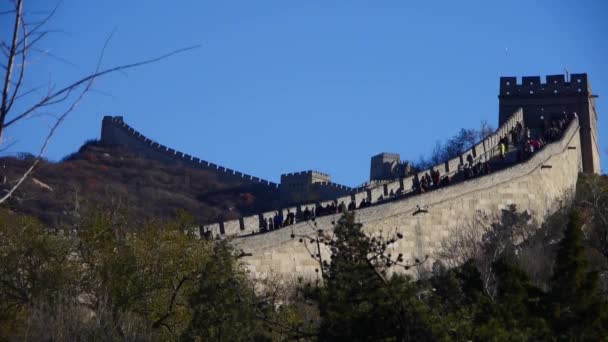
[0,175,608,341]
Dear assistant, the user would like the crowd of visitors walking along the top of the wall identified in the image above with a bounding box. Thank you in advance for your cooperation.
[255,113,576,235]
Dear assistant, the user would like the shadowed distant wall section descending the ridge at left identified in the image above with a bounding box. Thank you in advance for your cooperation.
[101,116,278,188]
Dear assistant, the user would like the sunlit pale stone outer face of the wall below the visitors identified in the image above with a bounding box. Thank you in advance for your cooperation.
[234,119,582,278]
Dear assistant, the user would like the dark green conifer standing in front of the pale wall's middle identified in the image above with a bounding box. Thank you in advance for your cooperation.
[310,213,430,341]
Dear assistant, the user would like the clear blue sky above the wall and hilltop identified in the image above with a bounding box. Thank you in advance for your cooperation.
[0,0,608,185]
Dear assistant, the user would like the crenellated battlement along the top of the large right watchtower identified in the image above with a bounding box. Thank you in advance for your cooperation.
[499,74,591,97]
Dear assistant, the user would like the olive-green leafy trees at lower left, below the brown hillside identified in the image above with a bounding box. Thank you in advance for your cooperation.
[0,211,270,340]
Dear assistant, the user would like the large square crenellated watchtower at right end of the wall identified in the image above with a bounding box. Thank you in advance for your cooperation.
[498,74,600,173]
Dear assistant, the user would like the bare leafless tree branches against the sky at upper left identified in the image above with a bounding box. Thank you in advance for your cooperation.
[0,0,198,203]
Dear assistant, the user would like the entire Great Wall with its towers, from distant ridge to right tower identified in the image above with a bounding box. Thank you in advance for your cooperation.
[102,74,600,277]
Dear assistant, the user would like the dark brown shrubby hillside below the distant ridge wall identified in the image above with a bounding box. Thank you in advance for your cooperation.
[0,141,278,226]
